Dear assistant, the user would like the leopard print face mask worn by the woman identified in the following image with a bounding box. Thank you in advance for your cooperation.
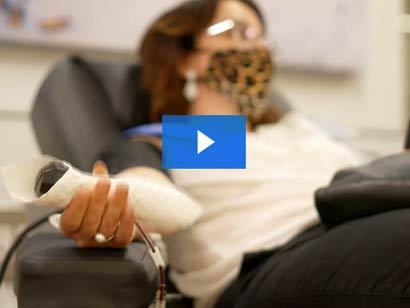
[205,48,274,123]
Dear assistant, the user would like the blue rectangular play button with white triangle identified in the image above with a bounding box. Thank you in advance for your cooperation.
[162,115,246,169]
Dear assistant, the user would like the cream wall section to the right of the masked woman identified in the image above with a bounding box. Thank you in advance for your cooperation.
[276,0,407,130]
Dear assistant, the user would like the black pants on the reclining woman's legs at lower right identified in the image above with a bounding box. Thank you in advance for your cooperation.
[216,210,410,308]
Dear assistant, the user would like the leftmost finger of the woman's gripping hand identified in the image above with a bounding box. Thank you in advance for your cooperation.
[60,187,91,236]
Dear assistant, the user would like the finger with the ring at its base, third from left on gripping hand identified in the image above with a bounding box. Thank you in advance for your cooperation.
[98,184,128,237]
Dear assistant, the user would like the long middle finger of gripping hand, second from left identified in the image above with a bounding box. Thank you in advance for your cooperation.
[79,178,111,240]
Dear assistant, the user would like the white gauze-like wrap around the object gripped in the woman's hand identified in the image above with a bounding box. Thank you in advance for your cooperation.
[1,155,202,234]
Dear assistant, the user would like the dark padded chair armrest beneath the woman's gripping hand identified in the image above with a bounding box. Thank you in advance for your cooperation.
[14,232,158,308]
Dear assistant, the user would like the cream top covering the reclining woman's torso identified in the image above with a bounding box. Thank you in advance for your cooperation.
[162,112,357,307]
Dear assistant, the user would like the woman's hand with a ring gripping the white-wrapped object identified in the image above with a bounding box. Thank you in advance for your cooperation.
[60,162,136,248]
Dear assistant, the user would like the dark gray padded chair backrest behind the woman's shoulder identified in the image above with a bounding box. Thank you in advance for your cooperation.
[31,58,148,171]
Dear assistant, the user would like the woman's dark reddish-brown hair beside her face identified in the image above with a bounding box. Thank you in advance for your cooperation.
[139,0,274,121]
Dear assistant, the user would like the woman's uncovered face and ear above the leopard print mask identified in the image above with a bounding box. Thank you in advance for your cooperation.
[185,0,265,76]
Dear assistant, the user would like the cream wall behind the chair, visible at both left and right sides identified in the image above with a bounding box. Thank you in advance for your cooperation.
[0,0,407,199]
